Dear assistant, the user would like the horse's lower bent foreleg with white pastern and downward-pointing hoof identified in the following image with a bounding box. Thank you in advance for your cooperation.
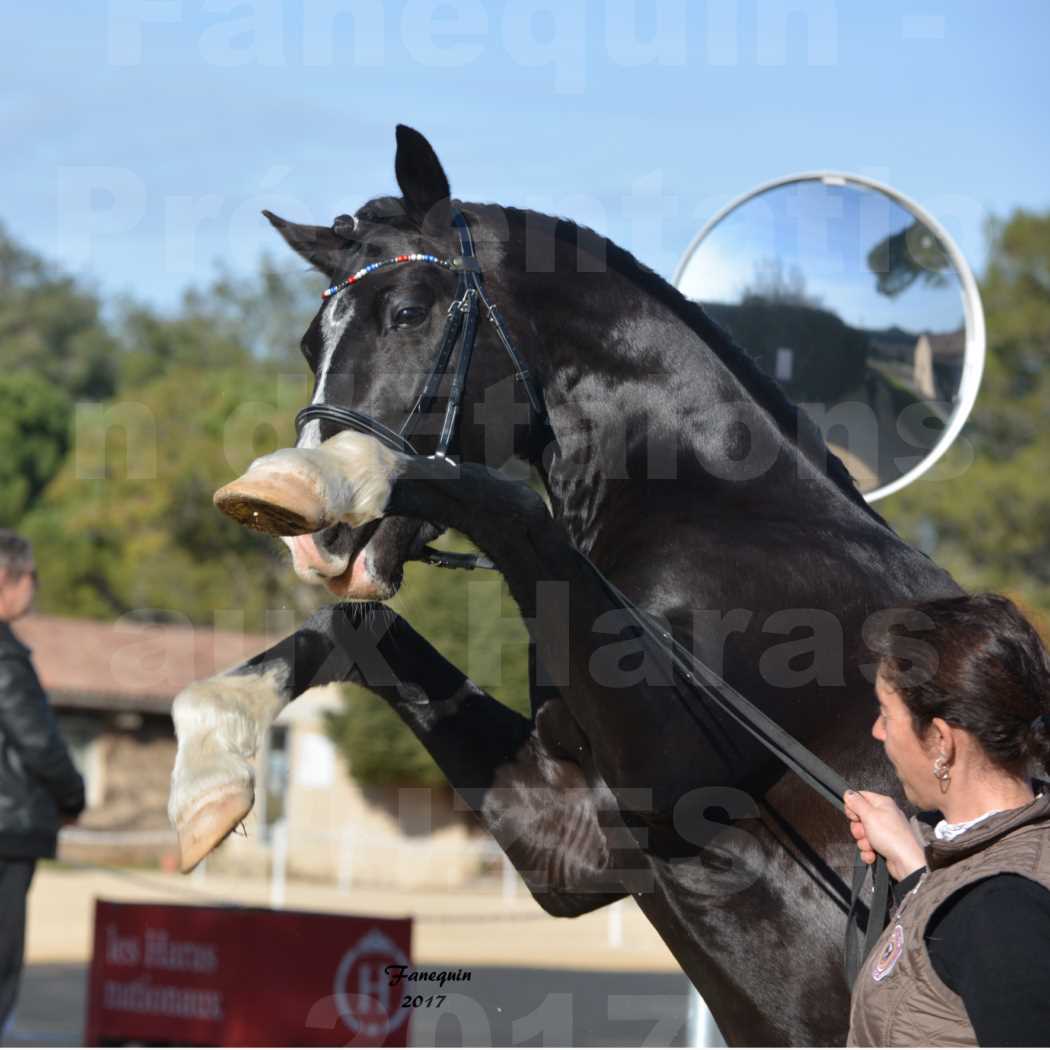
[170,603,630,915]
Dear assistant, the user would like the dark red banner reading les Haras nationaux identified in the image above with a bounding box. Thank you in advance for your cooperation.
[84,901,412,1047]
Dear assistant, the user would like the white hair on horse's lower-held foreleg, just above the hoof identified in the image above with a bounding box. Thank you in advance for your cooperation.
[168,668,288,827]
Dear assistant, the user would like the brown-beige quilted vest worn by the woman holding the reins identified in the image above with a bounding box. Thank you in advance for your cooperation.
[847,791,1050,1047]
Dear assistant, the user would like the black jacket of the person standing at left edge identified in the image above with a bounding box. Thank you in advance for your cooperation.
[0,623,84,858]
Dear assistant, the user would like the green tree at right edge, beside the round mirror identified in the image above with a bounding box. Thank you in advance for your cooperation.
[880,211,1050,612]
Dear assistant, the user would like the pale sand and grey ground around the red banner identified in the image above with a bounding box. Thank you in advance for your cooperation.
[3,864,689,1046]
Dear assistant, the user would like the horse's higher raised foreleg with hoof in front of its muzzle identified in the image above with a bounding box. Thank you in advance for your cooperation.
[215,432,764,810]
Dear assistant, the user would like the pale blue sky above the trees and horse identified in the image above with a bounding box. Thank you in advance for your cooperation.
[0,0,1050,308]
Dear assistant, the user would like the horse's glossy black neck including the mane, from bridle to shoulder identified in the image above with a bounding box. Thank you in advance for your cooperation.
[464,204,885,550]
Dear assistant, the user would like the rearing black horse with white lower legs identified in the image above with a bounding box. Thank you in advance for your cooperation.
[171,127,958,1045]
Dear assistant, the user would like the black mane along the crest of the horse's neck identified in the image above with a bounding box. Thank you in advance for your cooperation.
[503,208,889,528]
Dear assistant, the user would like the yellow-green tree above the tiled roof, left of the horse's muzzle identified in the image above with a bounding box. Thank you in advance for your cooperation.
[21,368,316,631]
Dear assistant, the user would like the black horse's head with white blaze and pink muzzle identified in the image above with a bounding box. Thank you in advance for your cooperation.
[265,125,529,601]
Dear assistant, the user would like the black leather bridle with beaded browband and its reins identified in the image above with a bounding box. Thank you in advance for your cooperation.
[295,208,889,987]
